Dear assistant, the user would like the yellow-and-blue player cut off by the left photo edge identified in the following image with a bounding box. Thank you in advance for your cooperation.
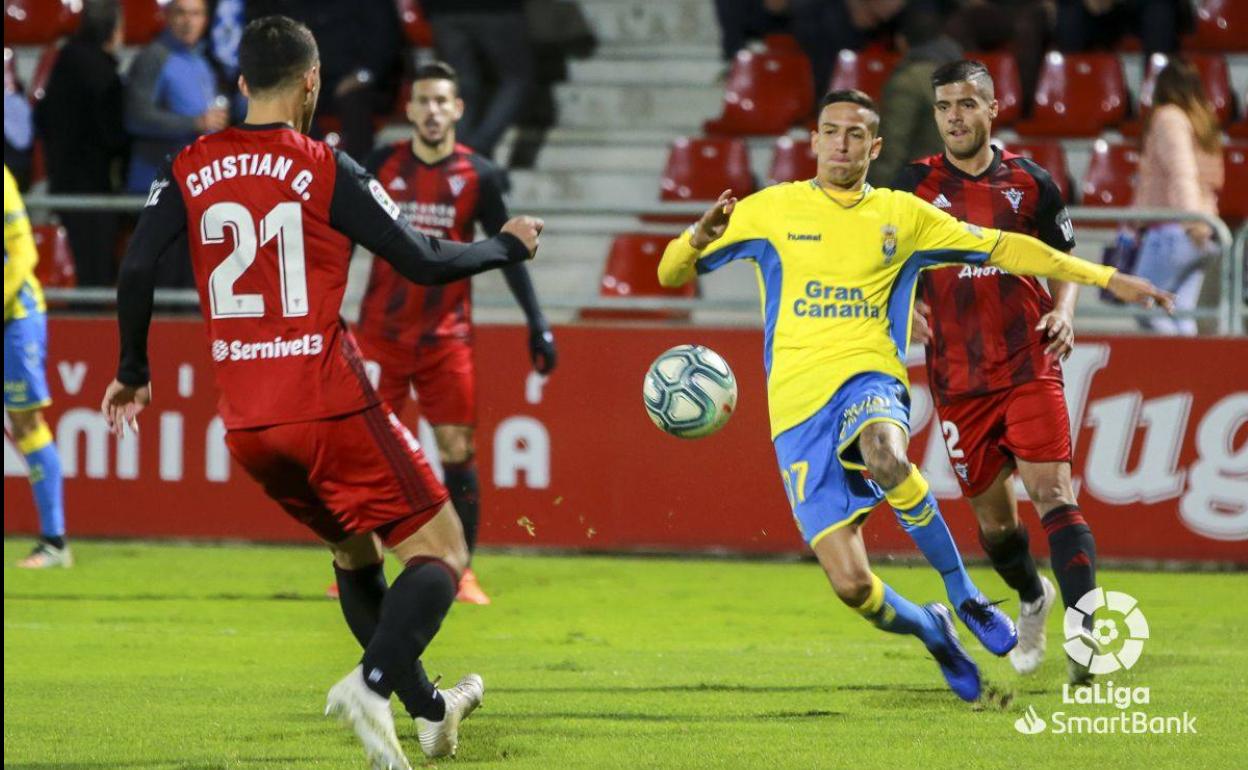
[4,166,74,569]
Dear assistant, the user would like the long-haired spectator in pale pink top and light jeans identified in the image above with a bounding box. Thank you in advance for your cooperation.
[1134,60,1226,334]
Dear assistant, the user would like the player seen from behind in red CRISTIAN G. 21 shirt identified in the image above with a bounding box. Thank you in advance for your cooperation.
[102,16,542,769]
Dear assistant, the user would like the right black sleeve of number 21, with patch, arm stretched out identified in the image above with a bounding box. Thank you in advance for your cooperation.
[329,151,529,285]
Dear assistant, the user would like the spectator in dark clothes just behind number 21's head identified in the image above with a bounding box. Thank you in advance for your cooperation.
[253,0,404,161]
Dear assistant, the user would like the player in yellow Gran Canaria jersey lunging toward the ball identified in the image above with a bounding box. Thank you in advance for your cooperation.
[659,91,1173,700]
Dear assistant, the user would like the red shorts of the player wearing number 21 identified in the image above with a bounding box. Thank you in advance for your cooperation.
[226,406,448,545]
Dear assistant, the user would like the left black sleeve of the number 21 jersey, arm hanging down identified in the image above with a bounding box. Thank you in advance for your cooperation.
[117,165,191,386]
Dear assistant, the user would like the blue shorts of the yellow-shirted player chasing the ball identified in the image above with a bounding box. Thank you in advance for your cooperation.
[775,372,910,547]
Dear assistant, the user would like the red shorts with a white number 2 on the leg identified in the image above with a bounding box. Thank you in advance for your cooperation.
[936,379,1071,497]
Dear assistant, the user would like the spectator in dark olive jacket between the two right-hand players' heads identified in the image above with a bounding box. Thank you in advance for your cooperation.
[867,5,962,187]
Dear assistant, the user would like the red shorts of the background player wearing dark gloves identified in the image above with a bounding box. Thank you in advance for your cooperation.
[357,337,477,426]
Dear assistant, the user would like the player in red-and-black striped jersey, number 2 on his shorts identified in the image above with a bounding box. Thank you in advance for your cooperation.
[894,61,1096,684]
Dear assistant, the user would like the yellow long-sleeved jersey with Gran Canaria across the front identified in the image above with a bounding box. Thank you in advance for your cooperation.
[660,180,1113,438]
